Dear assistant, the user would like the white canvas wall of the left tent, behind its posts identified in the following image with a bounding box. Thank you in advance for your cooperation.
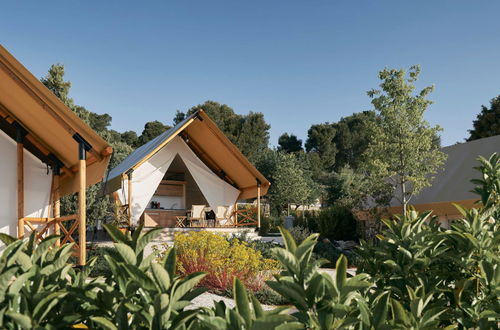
[0,131,52,250]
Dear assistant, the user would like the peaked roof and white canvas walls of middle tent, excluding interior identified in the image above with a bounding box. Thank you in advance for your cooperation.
[106,110,270,225]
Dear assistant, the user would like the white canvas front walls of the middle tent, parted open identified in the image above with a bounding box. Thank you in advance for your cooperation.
[118,136,240,224]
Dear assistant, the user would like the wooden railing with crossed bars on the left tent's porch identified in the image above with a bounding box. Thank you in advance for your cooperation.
[19,214,80,249]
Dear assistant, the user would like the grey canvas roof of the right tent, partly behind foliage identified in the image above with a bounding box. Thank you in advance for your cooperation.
[391,135,500,206]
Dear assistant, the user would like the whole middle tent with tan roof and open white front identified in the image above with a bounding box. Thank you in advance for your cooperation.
[106,110,270,227]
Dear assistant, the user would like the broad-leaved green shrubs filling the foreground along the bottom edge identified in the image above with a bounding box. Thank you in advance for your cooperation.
[0,156,500,330]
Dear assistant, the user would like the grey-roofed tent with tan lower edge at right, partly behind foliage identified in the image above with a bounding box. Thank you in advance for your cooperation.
[360,135,500,226]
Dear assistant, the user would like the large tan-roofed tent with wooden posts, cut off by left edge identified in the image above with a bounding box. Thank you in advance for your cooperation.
[0,46,112,264]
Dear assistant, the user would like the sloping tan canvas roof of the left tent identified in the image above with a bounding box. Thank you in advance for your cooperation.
[0,45,112,195]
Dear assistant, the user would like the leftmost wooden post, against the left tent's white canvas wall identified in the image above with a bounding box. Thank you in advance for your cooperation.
[14,122,26,239]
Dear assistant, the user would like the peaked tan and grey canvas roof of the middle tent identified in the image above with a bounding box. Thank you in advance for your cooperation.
[106,110,270,199]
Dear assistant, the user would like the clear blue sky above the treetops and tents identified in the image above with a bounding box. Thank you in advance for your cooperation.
[0,0,500,145]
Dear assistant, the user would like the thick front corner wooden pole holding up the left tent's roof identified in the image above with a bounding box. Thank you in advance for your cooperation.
[78,142,87,266]
